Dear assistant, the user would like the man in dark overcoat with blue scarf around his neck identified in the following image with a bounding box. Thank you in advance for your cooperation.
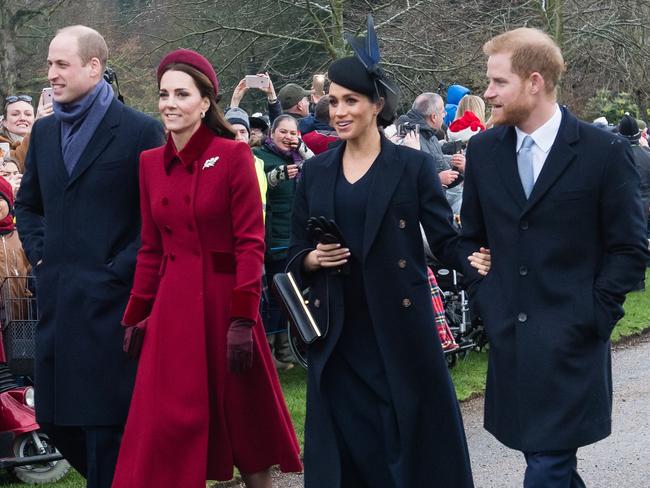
[16,26,163,488]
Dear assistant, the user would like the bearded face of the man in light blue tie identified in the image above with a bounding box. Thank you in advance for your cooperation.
[483,52,535,126]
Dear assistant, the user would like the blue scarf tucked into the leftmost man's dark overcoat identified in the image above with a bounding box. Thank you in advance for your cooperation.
[54,79,113,175]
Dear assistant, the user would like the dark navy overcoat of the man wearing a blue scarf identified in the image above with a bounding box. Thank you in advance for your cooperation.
[16,100,164,425]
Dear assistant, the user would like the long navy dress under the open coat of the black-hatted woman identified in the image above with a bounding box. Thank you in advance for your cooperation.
[322,160,399,488]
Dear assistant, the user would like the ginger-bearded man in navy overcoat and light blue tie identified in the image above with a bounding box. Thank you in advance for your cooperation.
[461,28,647,488]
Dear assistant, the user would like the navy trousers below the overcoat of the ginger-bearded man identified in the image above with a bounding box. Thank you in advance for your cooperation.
[524,449,585,488]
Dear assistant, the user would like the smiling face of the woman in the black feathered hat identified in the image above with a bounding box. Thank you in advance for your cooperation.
[329,83,381,140]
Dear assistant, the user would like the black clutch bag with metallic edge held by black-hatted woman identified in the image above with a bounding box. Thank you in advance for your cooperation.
[273,272,324,344]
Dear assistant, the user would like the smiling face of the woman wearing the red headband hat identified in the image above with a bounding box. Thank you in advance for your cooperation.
[158,70,210,140]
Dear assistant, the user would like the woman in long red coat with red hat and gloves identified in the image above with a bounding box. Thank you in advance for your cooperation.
[113,50,302,488]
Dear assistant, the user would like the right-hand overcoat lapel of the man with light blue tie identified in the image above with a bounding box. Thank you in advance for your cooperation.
[524,109,578,212]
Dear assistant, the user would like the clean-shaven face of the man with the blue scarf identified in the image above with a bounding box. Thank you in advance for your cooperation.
[47,34,103,103]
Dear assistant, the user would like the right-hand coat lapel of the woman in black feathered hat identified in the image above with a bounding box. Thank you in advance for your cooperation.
[363,136,405,259]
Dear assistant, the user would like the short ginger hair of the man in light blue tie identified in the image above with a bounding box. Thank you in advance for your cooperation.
[483,27,565,93]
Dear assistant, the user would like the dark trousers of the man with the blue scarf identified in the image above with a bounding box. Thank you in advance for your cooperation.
[39,423,123,488]
